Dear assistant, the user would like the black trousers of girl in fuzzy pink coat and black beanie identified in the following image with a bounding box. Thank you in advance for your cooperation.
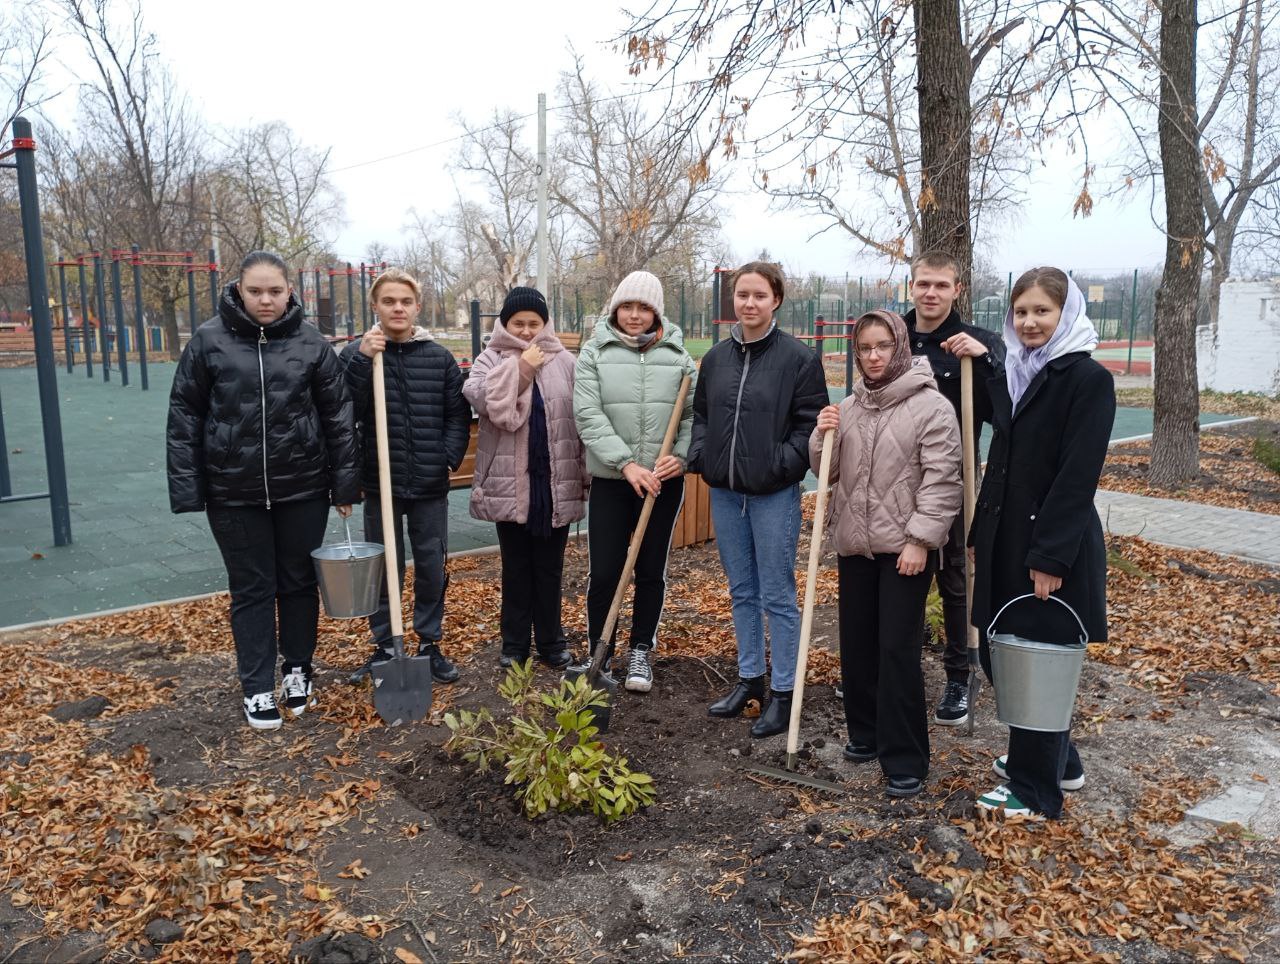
[497,522,568,659]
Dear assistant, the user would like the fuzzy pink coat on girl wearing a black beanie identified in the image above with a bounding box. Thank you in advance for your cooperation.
[462,324,589,527]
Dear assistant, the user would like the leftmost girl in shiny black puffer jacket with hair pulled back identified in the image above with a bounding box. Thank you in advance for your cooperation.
[168,251,360,730]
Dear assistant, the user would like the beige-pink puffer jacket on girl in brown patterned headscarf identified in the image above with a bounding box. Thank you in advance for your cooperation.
[809,356,963,557]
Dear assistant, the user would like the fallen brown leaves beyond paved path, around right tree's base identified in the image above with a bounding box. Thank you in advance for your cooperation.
[1100,433,1280,515]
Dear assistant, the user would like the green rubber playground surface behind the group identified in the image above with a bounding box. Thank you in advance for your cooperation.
[0,362,1230,629]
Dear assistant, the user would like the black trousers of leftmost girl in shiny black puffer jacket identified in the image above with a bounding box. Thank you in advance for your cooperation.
[207,499,329,696]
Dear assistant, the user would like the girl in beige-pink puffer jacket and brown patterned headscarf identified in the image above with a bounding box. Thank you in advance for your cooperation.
[809,311,961,796]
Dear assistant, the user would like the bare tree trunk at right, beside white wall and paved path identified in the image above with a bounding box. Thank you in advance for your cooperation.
[1151,0,1204,485]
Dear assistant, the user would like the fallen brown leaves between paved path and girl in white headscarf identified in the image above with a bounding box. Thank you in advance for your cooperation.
[1089,536,1280,695]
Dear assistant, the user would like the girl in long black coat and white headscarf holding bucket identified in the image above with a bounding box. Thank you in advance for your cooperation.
[969,268,1116,819]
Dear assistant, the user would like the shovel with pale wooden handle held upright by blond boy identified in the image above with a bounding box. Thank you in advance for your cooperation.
[369,352,431,726]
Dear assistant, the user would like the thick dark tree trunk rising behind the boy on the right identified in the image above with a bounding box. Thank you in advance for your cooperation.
[913,0,973,319]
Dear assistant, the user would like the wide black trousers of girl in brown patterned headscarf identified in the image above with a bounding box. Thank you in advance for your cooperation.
[837,553,934,780]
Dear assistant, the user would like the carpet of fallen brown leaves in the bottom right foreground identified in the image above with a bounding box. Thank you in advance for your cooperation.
[790,817,1274,961]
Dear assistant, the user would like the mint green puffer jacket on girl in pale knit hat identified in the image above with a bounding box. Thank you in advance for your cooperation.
[573,317,698,479]
